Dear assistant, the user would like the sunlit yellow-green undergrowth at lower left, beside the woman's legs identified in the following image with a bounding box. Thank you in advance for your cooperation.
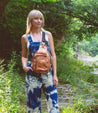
[0,61,26,113]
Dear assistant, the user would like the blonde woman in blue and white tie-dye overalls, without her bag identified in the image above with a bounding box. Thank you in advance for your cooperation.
[21,10,59,113]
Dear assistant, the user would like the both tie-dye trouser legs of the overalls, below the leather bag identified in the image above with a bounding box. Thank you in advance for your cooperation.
[26,70,59,113]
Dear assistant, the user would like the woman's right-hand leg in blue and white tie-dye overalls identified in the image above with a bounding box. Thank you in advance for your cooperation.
[42,71,59,113]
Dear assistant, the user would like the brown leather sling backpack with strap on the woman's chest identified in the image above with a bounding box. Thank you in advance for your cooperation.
[31,32,51,73]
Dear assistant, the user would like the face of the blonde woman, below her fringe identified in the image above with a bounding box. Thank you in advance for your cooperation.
[32,15,43,28]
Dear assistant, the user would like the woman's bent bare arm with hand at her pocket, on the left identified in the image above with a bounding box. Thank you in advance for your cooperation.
[21,35,32,72]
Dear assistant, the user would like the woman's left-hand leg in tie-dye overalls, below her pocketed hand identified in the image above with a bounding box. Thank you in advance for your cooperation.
[26,73,42,113]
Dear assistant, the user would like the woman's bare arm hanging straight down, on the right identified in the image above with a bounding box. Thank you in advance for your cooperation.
[48,32,58,87]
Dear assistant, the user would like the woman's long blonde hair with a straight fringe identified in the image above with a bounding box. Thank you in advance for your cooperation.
[26,10,44,34]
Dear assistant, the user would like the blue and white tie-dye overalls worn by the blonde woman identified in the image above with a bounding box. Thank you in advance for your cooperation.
[26,33,59,113]
